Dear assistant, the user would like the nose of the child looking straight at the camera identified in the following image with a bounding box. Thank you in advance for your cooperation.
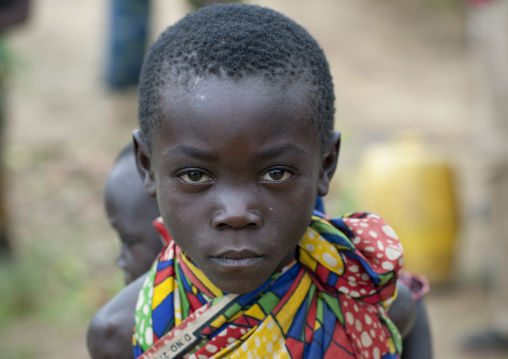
[212,190,263,229]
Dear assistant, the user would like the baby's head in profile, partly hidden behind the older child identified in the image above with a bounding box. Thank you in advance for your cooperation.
[104,159,162,284]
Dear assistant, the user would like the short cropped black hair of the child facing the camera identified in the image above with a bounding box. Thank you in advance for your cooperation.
[138,4,335,148]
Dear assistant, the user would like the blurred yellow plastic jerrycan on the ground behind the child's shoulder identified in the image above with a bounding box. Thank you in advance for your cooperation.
[357,134,458,283]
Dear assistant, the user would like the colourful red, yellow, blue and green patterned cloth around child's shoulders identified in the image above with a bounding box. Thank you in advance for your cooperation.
[133,211,403,359]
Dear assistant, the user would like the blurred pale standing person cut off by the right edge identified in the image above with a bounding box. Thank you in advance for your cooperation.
[464,0,508,351]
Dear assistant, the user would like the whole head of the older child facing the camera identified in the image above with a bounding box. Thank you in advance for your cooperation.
[134,5,339,293]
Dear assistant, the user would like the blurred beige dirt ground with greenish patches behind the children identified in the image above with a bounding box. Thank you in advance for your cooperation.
[0,0,503,359]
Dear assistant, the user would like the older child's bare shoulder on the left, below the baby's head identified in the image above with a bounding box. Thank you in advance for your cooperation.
[86,274,147,359]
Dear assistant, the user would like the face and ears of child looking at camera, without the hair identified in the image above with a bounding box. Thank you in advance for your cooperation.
[135,78,336,293]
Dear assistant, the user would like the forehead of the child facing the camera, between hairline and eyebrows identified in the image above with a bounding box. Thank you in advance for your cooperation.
[152,76,319,152]
